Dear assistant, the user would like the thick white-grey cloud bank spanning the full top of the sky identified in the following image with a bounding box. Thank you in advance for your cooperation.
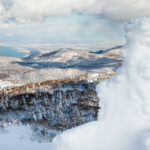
[0,0,150,23]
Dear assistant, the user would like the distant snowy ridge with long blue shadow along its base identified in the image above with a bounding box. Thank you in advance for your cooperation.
[21,47,121,70]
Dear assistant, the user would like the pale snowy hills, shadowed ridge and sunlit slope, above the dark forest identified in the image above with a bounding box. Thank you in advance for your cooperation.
[0,49,121,83]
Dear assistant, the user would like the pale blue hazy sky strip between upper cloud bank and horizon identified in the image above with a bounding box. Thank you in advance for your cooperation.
[0,14,124,43]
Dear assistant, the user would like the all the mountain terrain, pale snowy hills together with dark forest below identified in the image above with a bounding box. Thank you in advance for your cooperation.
[0,49,121,142]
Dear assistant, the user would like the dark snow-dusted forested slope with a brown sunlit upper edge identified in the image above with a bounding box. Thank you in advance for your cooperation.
[0,76,109,141]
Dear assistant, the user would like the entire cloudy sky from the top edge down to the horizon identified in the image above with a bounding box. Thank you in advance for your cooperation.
[0,0,150,43]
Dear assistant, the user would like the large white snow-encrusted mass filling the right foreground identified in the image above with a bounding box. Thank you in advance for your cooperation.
[0,17,150,150]
